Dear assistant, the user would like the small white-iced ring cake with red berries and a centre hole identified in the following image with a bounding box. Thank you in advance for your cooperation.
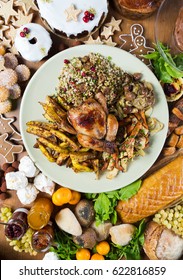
[15,23,52,62]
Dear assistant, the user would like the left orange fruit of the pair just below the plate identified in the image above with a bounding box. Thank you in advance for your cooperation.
[52,187,72,206]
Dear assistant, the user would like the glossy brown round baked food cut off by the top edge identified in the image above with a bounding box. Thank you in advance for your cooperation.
[113,0,163,20]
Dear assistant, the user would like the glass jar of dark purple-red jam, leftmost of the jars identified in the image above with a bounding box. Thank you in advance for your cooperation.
[5,208,29,240]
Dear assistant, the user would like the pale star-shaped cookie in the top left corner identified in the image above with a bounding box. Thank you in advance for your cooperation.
[0,0,17,24]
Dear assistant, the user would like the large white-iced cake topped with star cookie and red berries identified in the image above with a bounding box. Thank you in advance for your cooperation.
[37,0,108,39]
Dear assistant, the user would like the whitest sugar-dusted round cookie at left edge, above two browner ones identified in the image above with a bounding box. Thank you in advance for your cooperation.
[0,69,18,86]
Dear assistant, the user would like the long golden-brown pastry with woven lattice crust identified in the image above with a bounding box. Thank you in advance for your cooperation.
[116,155,183,223]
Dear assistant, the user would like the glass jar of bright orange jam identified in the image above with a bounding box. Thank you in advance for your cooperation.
[27,197,53,230]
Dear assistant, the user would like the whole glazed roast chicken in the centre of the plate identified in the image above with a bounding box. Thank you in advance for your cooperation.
[68,98,118,154]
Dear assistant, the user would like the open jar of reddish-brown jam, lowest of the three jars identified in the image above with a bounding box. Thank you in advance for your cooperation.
[32,221,54,252]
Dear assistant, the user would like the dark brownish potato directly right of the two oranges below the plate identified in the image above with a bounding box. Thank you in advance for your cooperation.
[75,199,95,227]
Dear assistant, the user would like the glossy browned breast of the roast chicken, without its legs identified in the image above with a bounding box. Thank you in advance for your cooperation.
[68,98,107,139]
